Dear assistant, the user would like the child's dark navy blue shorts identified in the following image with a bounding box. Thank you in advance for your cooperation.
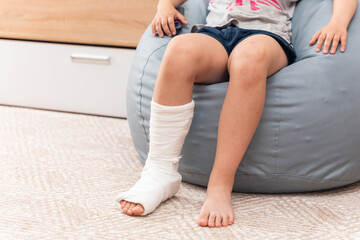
[196,25,296,65]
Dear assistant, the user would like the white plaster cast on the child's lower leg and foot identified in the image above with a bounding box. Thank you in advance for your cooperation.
[116,100,195,215]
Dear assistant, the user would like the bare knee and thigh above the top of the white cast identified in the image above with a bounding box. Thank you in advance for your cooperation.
[153,33,229,106]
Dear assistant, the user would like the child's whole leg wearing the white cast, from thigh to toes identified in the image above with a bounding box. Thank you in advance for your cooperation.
[117,33,228,215]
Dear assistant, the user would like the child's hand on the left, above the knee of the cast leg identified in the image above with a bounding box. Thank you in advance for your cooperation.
[151,5,188,37]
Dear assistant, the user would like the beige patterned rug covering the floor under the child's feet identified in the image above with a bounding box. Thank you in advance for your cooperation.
[0,106,360,240]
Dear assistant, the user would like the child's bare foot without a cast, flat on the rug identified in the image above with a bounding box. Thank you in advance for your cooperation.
[198,174,234,227]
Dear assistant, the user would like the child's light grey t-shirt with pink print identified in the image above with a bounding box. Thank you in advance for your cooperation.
[191,0,299,43]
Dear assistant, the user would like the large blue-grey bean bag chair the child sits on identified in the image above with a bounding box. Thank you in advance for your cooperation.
[127,0,360,193]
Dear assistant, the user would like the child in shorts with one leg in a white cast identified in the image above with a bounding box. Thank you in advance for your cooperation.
[116,0,357,227]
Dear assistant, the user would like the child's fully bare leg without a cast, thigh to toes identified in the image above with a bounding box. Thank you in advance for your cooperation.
[199,35,287,227]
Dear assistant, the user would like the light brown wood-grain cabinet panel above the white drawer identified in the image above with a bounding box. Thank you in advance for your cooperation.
[0,0,158,47]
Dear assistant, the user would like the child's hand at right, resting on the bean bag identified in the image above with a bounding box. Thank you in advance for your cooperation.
[309,22,347,54]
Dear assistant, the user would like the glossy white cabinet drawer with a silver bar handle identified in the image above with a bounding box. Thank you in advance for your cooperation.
[0,40,135,117]
